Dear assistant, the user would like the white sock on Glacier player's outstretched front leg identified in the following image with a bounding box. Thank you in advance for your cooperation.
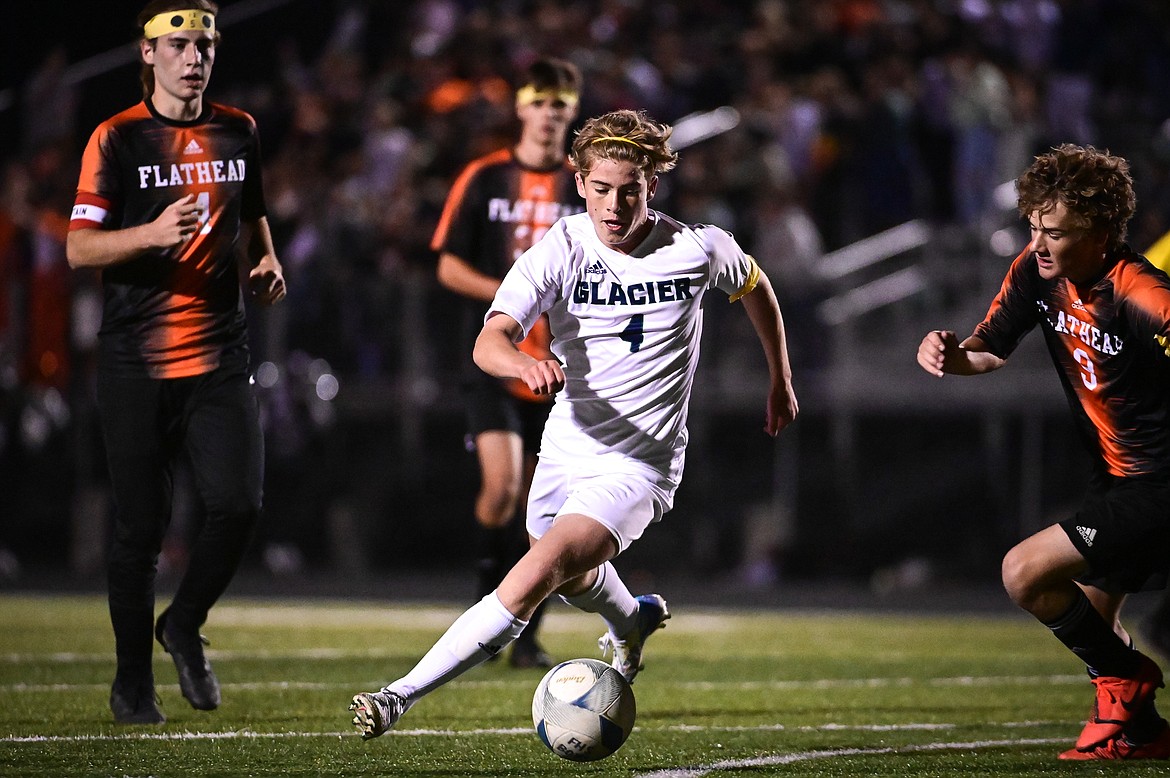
[383,592,528,703]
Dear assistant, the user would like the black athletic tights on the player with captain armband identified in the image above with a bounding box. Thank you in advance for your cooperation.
[97,369,263,674]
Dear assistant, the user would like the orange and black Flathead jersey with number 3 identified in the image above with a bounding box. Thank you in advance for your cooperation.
[975,248,1170,477]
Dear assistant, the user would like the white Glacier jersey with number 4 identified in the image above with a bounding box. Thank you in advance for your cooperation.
[488,211,759,487]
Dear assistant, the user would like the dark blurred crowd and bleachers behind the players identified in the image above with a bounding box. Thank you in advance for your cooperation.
[0,0,1170,590]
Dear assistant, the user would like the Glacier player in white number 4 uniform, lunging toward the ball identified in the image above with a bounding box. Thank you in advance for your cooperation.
[350,110,797,739]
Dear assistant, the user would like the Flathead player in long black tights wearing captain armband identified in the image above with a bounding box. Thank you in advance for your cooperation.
[66,0,284,724]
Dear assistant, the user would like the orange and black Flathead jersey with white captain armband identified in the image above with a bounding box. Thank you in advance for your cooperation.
[69,101,266,378]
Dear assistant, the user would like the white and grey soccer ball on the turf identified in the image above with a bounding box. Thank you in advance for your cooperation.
[532,659,635,762]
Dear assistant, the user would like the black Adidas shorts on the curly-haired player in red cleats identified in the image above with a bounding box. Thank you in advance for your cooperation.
[1060,476,1170,594]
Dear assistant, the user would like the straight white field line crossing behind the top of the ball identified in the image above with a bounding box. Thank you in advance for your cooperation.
[0,669,1085,694]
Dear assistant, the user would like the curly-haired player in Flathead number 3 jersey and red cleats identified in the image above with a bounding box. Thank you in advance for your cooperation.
[917,144,1170,759]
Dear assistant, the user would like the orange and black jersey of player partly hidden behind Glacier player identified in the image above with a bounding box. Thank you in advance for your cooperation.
[431,149,584,399]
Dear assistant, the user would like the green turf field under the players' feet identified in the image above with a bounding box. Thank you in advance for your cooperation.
[0,595,1170,778]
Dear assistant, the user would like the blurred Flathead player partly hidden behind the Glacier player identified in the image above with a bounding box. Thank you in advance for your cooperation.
[431,58,581,667]
